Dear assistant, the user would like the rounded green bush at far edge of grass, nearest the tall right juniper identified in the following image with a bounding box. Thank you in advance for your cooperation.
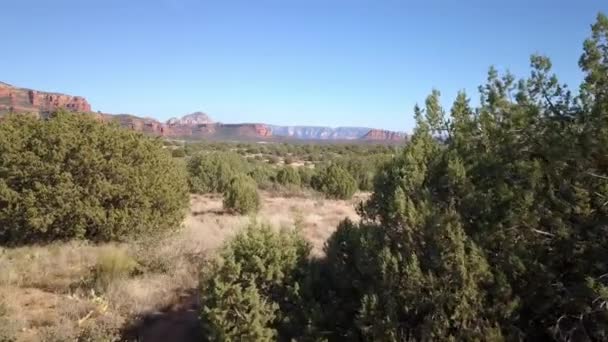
[311,164,357,199]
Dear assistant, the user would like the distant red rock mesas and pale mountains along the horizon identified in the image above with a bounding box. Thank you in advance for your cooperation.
[0,82,407,142]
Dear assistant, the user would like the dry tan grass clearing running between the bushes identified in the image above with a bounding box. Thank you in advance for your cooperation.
[0,193,365,341]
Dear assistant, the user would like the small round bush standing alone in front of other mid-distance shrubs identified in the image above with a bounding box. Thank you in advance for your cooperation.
[224,175,260,214]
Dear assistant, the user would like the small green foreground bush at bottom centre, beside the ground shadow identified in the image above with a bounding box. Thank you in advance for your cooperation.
[201,224,310,341]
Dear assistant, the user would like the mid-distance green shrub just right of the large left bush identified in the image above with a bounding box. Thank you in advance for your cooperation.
[187,152,247,193]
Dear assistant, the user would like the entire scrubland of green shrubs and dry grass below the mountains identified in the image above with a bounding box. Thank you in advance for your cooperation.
[0,14,608,341]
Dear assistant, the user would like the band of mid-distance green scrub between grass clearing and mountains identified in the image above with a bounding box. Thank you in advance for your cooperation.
[178,135,397,197]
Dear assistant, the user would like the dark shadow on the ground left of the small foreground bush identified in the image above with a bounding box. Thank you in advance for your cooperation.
[123,290,203,342]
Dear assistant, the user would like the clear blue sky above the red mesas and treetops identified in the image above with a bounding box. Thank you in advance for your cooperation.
[0,0,608,131]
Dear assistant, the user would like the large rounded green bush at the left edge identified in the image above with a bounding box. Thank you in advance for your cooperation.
[0,112,188,245]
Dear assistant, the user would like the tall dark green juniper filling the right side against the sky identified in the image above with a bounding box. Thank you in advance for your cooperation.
[354,16,608,340]
